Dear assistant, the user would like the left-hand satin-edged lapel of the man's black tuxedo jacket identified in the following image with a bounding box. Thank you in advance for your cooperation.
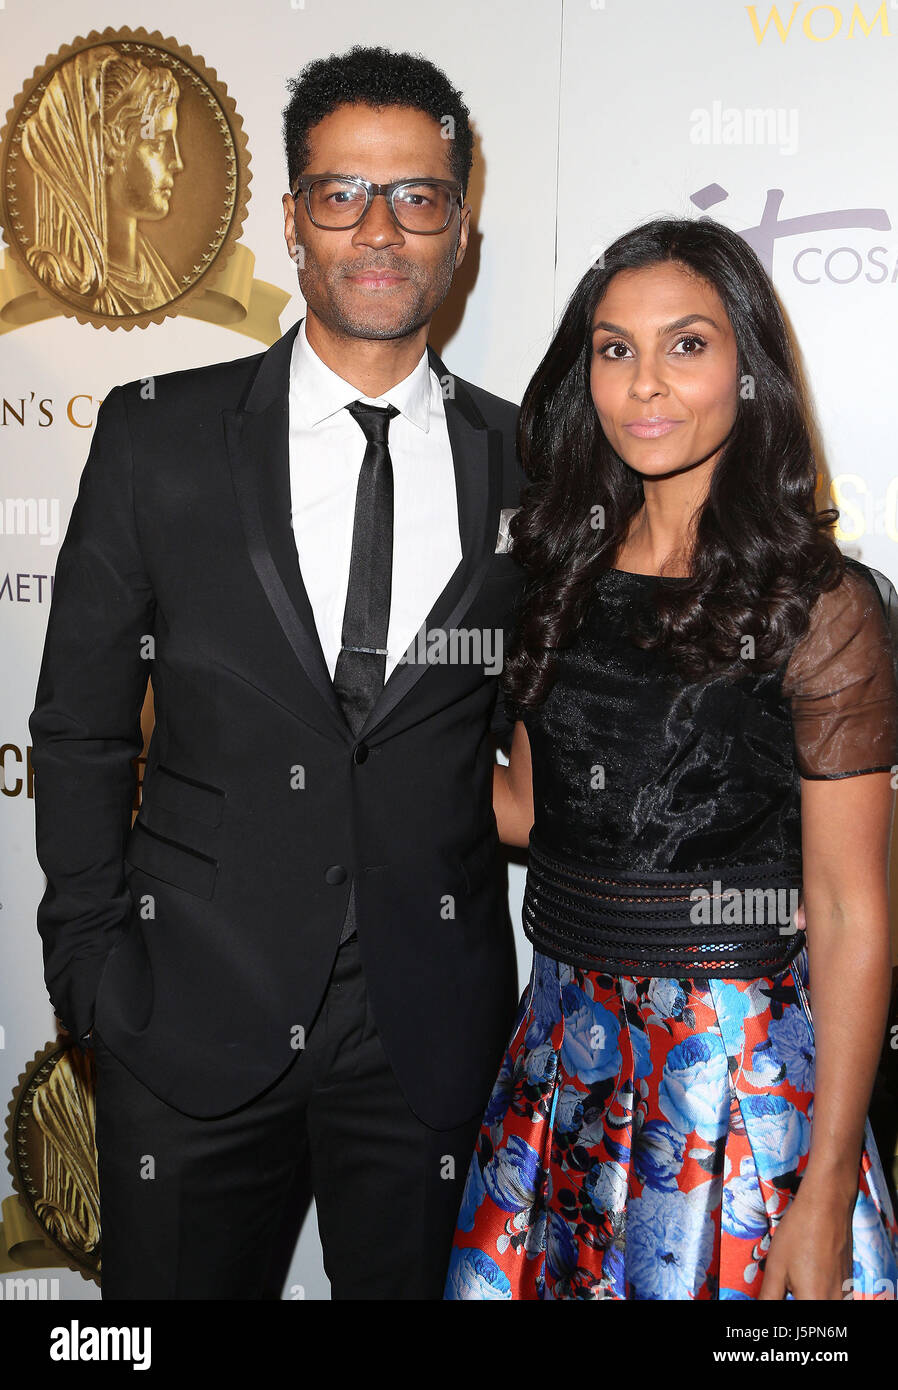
[222,321,352,739]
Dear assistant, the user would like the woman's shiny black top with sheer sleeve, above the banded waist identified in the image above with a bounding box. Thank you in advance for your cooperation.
[523,560,898,872]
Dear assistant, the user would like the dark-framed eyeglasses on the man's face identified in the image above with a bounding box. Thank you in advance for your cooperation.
[293,174,462,236]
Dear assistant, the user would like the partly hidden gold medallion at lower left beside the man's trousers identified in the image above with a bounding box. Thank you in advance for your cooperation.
[0,1041,100,1279]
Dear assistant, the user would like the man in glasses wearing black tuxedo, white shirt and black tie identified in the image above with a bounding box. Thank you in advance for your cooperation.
[31,49,523,1298]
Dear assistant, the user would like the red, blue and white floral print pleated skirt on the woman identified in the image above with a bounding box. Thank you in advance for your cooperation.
[445,948,898,1300]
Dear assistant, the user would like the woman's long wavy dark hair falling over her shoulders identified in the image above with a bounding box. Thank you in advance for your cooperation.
[503,218,844,709]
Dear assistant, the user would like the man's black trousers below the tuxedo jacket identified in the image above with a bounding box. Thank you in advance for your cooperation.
[93,935,481,1300]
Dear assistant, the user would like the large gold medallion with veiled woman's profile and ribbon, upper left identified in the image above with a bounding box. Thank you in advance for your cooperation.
[0,29,289,342]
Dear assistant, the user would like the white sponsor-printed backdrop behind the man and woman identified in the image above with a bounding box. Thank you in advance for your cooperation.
[0,0,898,1298]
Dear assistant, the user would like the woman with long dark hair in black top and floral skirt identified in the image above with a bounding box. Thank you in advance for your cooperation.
[446,220,898,1300]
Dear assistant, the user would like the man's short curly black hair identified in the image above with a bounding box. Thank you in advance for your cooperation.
[284,44,474,196]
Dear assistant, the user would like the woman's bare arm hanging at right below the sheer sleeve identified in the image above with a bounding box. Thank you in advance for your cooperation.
[762,773,894,1298]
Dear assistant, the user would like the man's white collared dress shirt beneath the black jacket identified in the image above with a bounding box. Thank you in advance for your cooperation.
[289,320,462,681]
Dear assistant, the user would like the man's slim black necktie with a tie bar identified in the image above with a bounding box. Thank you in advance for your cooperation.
[334,400,399,734]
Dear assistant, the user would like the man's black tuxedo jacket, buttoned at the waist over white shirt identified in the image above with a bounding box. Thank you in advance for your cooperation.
[29,322,523,1129]
